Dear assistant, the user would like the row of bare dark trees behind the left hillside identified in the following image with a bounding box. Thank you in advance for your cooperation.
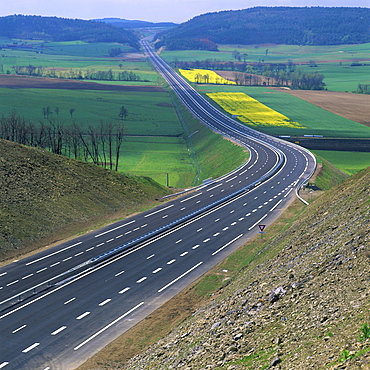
[0,110,125,171]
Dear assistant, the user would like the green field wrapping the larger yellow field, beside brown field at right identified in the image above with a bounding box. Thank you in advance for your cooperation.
[198,85,370,138]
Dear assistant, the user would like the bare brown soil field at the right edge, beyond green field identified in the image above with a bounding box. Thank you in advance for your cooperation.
[271,87,370,126]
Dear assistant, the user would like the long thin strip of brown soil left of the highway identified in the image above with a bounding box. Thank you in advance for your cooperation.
[0,75,165,92]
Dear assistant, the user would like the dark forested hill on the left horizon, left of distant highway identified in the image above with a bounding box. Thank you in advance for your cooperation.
[0,15,139,49]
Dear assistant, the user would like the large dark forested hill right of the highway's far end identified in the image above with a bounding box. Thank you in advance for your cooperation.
[157,7,370,50]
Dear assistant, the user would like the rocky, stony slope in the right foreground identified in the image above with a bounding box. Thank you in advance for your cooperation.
[125,168,370,370]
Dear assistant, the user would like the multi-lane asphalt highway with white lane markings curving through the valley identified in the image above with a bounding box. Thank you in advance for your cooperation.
[0,42,315,370]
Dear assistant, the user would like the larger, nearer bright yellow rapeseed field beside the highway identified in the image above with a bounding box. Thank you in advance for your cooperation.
[207,92,305,128]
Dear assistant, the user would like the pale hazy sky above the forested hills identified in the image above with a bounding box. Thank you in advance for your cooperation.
[0,0,370,23]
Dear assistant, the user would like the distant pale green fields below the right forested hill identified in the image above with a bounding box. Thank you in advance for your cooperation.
[161,44,370,92]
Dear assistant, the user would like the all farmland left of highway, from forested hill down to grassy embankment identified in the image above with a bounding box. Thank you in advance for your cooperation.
[0,40,246,188]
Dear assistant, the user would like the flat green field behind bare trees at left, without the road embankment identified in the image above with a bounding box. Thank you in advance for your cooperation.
[0,88,188,187]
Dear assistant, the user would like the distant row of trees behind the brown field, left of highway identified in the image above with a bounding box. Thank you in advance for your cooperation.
[12,65,148,82]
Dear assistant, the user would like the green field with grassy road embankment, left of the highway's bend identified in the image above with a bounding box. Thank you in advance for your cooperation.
[0,84,246,188]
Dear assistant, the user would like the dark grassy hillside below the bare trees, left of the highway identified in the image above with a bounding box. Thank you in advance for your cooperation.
[0,140,168,260]
